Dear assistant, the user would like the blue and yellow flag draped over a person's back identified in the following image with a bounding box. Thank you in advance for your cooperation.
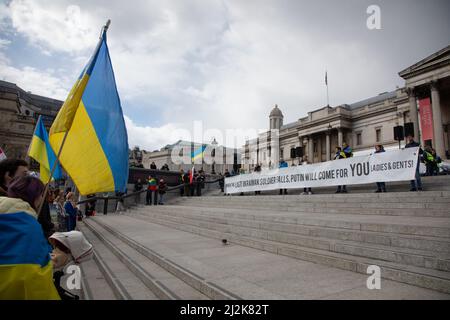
[0,198,60,300]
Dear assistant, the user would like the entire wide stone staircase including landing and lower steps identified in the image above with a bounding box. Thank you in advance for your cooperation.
[76,184,450,300]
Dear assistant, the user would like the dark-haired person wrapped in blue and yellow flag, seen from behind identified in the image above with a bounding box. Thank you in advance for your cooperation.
[0,176,60,300]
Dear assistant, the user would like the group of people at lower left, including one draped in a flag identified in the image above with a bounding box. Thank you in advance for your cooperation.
[0,159,92,300]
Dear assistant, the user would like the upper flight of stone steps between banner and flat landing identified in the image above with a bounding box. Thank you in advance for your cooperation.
[130,191,450,293]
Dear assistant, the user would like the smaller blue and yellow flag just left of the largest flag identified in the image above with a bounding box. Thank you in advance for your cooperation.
[28,116,62,183]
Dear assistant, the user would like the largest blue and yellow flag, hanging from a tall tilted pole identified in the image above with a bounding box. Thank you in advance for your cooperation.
[50,24,128,195]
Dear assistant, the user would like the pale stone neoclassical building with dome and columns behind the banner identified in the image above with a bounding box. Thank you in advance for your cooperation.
[242,46,450,171]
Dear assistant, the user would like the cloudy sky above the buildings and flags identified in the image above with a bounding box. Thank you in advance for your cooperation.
[0,0,450,150]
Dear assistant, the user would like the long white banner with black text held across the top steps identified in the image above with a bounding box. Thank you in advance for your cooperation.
[225,148,419,193]
